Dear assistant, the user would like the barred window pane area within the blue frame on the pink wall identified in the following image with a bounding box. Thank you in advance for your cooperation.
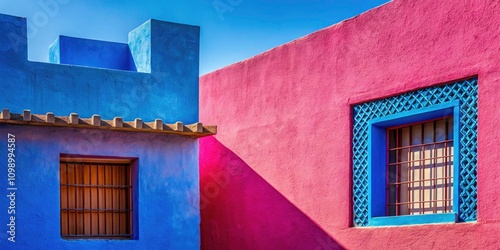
[387,117,453,216]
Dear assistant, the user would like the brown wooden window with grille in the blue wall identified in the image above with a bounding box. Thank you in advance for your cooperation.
[60,158,133,239]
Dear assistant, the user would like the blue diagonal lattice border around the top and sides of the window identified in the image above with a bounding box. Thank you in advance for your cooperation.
[352,78,478,226]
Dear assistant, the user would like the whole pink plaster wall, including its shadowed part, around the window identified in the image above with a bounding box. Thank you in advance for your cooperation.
[200,0,500,249]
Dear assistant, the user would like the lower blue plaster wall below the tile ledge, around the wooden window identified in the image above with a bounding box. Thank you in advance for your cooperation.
[0,124,200,250]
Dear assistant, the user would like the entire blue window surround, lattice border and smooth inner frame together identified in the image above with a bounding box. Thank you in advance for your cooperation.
[352,77,477,226]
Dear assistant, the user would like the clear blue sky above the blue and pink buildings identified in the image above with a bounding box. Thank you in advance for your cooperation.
[0,0,388,75]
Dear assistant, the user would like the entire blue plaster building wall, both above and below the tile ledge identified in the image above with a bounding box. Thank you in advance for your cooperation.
[0,14,200,249]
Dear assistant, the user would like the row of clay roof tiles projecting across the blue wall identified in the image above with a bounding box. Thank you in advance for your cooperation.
[0,109,217,137]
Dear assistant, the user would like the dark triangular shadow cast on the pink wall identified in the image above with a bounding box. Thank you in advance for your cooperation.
[200,137,344,250]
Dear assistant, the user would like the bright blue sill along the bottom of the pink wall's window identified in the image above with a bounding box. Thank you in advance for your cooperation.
[368,213,458,227]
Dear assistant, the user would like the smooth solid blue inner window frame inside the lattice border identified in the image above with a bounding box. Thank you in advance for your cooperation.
[368,100,460,226]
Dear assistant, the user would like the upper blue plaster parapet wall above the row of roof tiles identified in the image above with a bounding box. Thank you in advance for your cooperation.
[0,12,199,123]
